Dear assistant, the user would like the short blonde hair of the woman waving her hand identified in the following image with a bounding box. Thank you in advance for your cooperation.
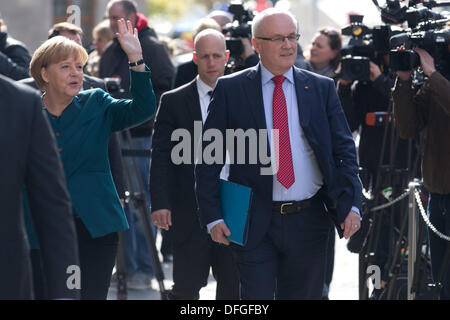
[30,36,88,90]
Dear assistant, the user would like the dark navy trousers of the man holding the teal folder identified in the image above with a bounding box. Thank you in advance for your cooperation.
[232,204,331,300]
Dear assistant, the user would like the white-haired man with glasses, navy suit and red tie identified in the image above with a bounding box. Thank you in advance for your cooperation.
[195,9,361,299]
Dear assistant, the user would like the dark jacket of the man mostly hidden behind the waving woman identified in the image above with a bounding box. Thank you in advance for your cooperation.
[19,74,125,199]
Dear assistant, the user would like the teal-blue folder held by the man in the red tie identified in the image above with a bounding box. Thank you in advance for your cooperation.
[220,179,252,246]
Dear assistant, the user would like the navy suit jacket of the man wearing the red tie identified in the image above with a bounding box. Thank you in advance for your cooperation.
[195,65,361,248]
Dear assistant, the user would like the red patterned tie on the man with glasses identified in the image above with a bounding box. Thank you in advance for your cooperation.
[272,76,295,189]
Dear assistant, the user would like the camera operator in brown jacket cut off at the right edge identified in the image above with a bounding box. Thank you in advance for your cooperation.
[392,43,450,299]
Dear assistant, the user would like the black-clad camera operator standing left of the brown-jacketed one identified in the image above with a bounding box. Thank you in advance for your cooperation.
[337,46,409,299]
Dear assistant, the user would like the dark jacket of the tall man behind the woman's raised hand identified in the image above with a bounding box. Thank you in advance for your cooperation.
[99,27,175,136]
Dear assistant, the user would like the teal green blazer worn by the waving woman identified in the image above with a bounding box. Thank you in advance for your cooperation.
[43,68,156,238]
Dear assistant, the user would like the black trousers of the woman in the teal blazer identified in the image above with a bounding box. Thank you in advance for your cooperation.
[75,218,119,300]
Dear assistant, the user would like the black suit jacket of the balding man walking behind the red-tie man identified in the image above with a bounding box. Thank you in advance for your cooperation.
[150,79,202,242]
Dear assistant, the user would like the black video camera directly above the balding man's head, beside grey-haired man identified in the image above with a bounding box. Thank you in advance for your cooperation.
[222,1,254,68]
